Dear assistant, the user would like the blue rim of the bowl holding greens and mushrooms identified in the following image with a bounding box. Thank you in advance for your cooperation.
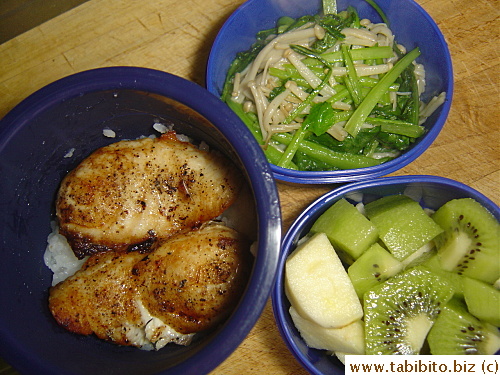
[205,0,454,184]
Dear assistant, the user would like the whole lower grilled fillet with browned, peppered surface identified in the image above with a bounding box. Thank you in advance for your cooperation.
[49,223,252,349]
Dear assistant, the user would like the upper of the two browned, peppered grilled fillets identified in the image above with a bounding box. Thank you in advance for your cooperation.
[56,132,242,259]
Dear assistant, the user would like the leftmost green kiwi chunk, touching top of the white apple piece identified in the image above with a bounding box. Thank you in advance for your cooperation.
[311,199,378,263]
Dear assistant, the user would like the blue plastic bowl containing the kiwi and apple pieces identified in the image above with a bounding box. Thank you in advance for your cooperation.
[272,176,500,375]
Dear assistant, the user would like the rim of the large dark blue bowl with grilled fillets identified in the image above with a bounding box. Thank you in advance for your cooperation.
[0,66,281,374]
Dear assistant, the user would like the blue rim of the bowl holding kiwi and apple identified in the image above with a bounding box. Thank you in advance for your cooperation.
[271,175,500,375]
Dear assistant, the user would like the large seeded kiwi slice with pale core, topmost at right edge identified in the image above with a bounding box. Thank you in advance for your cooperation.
[432,198,500,284]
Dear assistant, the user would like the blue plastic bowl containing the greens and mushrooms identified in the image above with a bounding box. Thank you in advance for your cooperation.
[206,0,453,184]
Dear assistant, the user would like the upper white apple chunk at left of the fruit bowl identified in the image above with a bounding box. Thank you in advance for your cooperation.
[285,233,363,328]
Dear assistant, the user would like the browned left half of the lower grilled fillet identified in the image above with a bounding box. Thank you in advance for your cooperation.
[49,251,144,345]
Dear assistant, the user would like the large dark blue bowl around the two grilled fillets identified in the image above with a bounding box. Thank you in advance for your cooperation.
[0,67,281,375]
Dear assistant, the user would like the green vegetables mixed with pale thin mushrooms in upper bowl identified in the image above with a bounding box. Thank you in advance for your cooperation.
[221,0,446,171]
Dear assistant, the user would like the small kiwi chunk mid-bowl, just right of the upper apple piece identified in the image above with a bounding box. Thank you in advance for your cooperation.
[347,243,403,298]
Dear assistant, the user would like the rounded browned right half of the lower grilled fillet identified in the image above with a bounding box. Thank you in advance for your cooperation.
[133,225,251,333]
